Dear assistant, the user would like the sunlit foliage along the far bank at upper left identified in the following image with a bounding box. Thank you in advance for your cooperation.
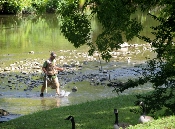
[0,0,64,14]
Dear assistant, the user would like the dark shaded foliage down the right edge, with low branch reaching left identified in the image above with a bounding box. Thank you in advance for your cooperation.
[117,3,175,113]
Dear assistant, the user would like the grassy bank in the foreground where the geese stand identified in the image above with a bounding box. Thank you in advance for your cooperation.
[0,95,175,129]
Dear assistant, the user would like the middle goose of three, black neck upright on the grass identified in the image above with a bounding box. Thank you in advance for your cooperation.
[114,109,129,129]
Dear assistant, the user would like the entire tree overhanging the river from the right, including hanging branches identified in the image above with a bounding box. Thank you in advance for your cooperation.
[60,0,175,115]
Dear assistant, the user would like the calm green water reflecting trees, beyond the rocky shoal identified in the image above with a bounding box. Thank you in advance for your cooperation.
[0,11,157,54]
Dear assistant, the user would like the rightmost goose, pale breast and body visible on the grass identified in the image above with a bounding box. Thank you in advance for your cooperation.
[139,101,154,123]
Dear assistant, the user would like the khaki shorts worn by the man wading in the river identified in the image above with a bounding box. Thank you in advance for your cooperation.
[43,77,60,89]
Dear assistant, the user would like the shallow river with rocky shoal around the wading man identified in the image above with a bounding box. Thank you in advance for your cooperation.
[0,14,157,114]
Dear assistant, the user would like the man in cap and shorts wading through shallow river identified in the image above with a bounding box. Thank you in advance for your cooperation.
[40,52,63,97]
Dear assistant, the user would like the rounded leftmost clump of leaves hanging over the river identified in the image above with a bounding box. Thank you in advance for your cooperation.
[61,2,91,48]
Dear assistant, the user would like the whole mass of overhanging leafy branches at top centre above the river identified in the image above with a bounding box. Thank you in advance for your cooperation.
[61,0,142,61]
